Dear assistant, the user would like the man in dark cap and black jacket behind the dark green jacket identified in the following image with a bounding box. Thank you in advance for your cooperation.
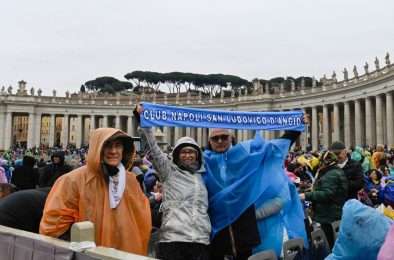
[329,141,364,199]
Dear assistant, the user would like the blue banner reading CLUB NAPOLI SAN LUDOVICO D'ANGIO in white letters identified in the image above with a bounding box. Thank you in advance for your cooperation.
[141,102,305,131]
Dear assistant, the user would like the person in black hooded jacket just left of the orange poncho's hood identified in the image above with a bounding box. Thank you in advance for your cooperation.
[39,152,73,188]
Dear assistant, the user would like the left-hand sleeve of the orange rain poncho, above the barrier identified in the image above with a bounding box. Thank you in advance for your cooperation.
[40,176,79,237]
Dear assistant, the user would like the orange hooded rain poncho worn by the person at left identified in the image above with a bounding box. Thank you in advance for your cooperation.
[40,128,151,255]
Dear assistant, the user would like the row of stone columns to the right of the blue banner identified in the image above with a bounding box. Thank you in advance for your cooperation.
[304,92,394,150]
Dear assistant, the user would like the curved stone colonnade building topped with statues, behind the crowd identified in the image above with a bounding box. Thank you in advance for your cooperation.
[0,55,394,149]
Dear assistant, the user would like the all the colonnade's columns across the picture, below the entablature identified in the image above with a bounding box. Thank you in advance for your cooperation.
[0,91,394,150]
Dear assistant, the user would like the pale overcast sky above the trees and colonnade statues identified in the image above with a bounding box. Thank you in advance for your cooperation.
[0,0,394,96]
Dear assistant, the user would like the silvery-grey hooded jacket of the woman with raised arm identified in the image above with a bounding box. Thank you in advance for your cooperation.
[139,128,211,245]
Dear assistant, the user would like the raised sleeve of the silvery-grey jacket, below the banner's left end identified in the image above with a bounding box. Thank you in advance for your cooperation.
[138,127,171,182]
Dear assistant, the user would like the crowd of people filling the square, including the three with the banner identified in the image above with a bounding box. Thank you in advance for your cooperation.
[0,104,394,260]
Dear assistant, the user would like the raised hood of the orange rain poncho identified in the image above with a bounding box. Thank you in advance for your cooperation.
[86,128,135,175]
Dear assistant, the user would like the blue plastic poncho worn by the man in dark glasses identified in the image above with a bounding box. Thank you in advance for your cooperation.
[203,132,307,255]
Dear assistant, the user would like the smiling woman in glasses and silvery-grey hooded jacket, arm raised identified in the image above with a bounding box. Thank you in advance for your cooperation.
[133,105,211,260]
